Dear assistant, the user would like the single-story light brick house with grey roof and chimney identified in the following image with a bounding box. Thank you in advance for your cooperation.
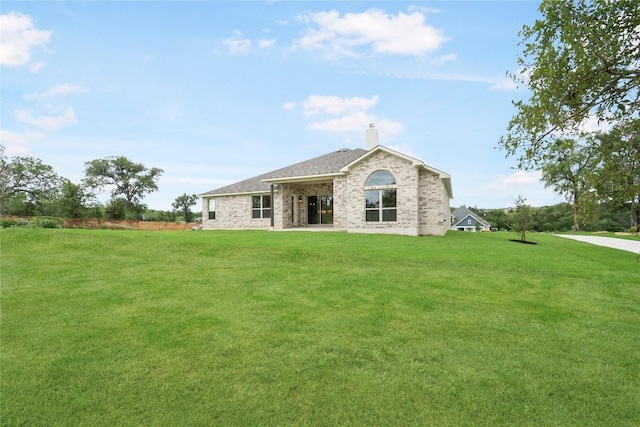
[199,125,453,236]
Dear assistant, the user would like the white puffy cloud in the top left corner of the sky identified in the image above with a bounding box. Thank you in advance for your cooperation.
[0,12,52,67]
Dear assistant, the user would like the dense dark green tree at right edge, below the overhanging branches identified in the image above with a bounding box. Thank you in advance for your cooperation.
[596,120,640,226]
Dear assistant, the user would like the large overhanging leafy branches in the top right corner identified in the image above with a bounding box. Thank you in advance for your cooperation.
[499,0,640,167]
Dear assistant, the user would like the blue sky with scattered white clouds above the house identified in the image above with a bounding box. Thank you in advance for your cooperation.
[0,1,562,210]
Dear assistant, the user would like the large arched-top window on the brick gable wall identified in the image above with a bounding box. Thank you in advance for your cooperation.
[364,170,398,222]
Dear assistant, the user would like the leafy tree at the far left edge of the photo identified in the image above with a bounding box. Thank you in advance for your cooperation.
[0,146,63,215]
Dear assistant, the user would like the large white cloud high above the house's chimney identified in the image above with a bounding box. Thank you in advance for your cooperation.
[293,8,448,58]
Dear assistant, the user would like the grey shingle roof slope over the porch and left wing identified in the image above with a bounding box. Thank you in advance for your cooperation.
[201,148,367,196]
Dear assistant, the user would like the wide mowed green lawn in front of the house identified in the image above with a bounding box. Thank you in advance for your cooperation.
[0,229,640,426]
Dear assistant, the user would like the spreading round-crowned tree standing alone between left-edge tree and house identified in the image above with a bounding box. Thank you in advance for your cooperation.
[83,156,163,213]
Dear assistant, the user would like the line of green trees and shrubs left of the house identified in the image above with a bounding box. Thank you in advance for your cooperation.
[0,145,197,222]
